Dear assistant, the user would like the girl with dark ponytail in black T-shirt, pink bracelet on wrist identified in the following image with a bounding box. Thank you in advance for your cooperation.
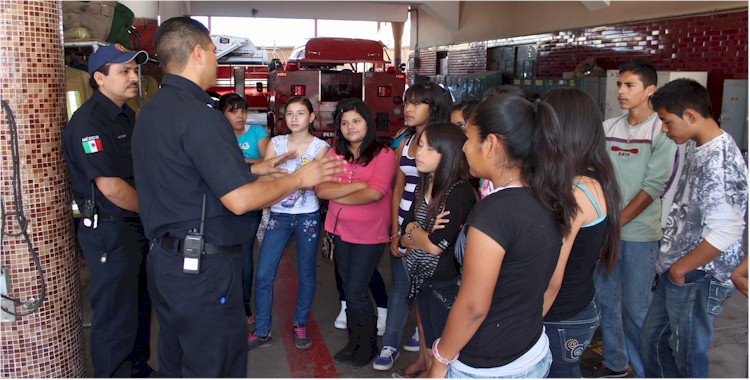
[429,94,577,377]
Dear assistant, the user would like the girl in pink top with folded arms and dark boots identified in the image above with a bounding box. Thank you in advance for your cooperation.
[316,99,396,368]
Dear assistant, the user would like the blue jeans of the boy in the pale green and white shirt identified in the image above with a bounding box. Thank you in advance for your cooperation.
[594,241,659,377]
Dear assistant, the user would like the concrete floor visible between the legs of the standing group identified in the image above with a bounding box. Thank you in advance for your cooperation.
[82,238,748,378]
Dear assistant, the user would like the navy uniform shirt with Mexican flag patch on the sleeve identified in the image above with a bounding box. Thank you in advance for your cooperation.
[62,91,138,217]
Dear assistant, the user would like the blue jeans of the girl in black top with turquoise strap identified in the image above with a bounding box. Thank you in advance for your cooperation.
[544,300,599,378]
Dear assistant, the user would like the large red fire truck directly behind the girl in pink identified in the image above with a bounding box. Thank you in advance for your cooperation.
[267,37,406,139]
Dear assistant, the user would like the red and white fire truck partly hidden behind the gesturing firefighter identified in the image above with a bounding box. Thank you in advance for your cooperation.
[206,35,282,119]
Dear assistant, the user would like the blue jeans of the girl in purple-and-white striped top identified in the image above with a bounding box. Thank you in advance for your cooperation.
[383,255,409,349]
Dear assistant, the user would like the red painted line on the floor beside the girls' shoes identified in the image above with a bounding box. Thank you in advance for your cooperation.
[273,251,339,378]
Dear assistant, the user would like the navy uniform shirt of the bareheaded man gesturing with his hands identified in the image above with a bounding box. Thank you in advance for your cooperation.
[133,74,255,246]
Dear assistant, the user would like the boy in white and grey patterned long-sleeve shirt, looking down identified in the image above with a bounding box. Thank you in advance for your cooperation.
[641,79,748,377]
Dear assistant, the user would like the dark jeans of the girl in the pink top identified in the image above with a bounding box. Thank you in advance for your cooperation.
[333,235,385,326]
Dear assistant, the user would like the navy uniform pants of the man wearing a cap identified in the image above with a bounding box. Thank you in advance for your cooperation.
[78,221,150,377]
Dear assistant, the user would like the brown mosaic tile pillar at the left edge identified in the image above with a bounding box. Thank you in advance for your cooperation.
[0,0,86,378]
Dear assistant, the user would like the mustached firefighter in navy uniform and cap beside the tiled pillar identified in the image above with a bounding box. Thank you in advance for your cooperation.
[62,44,151,377]
